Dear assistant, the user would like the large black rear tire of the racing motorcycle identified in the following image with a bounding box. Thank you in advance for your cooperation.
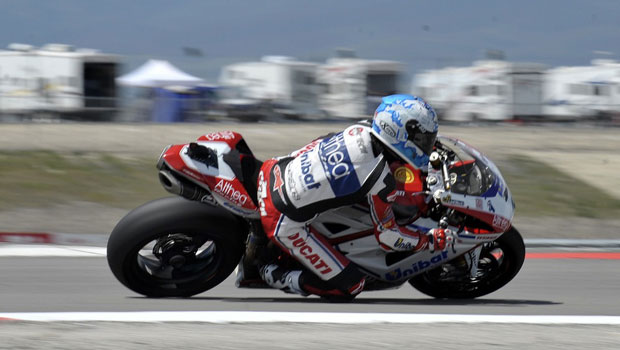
[107,197,247,297]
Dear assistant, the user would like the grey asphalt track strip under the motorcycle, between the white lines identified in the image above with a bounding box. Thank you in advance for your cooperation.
[0,252,620,316]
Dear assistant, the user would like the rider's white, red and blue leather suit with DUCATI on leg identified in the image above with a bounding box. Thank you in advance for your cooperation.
[258,125,428,295]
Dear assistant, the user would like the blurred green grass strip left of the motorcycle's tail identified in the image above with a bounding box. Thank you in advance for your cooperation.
[0,152,167,210]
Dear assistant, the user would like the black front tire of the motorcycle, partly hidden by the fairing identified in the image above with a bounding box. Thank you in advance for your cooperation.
[409,227,525,299]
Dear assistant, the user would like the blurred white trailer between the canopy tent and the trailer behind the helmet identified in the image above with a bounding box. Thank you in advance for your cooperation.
[219,56,321,118]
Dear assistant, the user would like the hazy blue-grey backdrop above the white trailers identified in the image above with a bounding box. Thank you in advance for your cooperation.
[0,0,620,80]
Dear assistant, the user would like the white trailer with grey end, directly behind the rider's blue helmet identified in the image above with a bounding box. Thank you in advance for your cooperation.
[317,57,404,119]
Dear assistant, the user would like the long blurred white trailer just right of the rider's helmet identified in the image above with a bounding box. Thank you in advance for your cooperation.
[412,60,545,121]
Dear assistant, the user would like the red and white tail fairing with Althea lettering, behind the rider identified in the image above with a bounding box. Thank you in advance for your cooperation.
[162,131,259,218]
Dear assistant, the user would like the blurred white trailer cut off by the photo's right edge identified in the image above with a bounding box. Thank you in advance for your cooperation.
[544,59,620,120]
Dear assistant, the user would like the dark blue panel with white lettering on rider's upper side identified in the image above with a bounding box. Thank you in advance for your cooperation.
[319,133,360,196]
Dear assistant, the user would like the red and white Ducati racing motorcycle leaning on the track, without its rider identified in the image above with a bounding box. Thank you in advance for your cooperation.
[107,131,525,299]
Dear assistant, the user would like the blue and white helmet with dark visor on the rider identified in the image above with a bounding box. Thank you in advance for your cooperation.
[372,95,439,170]
